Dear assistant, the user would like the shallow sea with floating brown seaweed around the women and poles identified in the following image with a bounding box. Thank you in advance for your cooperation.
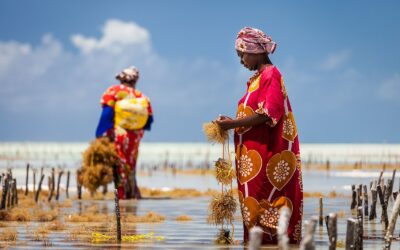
[0,143,400,249]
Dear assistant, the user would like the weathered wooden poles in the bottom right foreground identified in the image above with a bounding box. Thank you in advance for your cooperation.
[249,170,400,250]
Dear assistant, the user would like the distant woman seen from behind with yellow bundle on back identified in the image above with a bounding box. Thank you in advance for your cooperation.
[96,67,153,199]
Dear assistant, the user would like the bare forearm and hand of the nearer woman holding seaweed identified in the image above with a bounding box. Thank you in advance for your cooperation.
[215,114,270,130]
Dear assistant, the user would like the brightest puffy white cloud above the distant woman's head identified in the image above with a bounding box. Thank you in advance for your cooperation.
[71,19,150,54]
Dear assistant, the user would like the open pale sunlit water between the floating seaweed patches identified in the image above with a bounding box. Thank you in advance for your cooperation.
[0,143,400,249]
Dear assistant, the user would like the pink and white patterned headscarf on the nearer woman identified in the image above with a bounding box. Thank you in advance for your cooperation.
[235,27,276,54]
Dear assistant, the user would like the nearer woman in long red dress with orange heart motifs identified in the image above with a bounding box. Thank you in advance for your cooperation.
[216,27,303,244]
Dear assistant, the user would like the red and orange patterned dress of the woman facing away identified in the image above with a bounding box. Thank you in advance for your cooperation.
[101,84,153,199]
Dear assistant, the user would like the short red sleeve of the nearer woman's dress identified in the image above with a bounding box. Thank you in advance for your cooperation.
[256,70,285,127]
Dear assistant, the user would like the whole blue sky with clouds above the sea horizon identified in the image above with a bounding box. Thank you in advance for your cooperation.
[0,0,400,143]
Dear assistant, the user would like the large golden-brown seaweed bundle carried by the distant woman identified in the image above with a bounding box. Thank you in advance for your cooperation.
[78,137,120,193]
